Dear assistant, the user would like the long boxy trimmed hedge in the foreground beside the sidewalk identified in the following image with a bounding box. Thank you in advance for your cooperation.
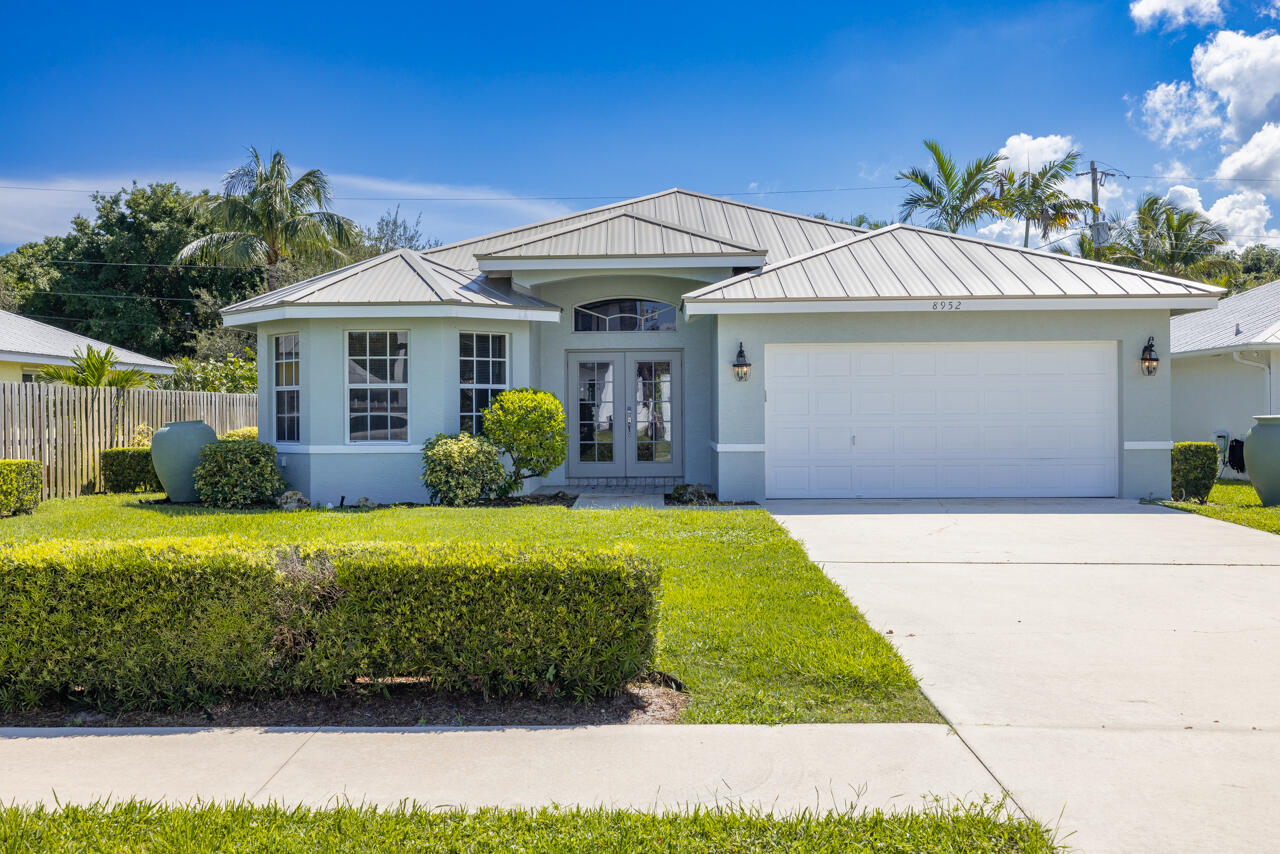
[0,538,659,708]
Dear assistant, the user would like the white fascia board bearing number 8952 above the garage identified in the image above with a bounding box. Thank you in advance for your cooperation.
[685,294,1217,315]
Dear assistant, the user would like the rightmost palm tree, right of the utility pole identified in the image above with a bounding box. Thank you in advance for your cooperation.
[1110,195,1233,282]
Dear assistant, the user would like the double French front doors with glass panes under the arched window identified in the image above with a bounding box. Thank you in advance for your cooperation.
[566,350,684,478]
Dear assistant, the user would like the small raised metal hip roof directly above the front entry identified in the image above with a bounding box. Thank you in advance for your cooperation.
[476,210,765,259]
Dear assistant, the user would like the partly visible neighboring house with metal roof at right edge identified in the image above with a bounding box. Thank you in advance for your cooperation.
[1170,282,1280,474]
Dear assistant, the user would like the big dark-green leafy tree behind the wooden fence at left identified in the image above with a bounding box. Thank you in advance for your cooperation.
[0,183,265,359]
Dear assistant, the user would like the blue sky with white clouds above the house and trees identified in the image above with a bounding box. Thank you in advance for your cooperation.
[0,0,1280,248]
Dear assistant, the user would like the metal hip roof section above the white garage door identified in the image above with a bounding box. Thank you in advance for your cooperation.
[685,224,1222,302]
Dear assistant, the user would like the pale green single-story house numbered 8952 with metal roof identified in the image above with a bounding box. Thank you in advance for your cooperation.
[223,189,1221,502]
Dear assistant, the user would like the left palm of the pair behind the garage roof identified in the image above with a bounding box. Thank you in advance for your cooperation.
[897,140,1004,232]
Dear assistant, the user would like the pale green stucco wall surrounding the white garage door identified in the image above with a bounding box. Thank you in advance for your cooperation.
[713,310,1171,501]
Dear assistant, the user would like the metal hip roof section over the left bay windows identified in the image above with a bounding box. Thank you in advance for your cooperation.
[223,248,559,314]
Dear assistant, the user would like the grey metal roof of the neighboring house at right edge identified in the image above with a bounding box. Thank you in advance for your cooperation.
[1169,280,1280,353]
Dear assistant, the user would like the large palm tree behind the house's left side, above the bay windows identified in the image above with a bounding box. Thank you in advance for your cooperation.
[178,147,361,291]
